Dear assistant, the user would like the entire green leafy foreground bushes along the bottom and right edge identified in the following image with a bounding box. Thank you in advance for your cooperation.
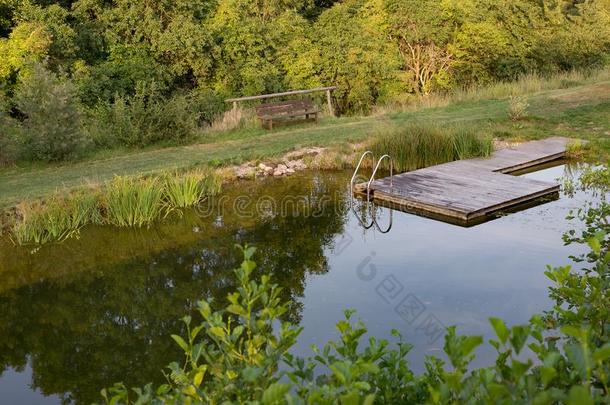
[102,190,610,404]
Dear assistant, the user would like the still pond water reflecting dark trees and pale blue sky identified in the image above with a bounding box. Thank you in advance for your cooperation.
[0,165,593,404]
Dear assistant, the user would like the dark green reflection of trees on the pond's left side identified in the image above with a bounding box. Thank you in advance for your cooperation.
[0,171,344,402]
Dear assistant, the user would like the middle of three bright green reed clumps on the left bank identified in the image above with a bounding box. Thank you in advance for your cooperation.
[102,176,164,227]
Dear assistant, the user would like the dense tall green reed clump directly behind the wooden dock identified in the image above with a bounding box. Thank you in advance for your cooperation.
[369,124,493,172]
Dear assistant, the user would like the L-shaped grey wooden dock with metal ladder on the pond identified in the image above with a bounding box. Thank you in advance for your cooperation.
[358,137,571,226]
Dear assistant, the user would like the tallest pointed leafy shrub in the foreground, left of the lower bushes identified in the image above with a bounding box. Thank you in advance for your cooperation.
[102,246,301,404]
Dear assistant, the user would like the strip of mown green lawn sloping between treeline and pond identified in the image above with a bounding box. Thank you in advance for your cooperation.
[0,81,610,208]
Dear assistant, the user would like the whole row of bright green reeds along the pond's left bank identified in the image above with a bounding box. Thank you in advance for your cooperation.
[10,171,221,245]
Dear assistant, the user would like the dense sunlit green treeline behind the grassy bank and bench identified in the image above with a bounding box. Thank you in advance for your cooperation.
[0,0,610,161]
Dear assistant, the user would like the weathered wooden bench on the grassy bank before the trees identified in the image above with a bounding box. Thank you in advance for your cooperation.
[256,99,320,129]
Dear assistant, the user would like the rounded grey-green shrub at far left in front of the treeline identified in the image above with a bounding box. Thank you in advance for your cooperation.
[14,65,89,161]
